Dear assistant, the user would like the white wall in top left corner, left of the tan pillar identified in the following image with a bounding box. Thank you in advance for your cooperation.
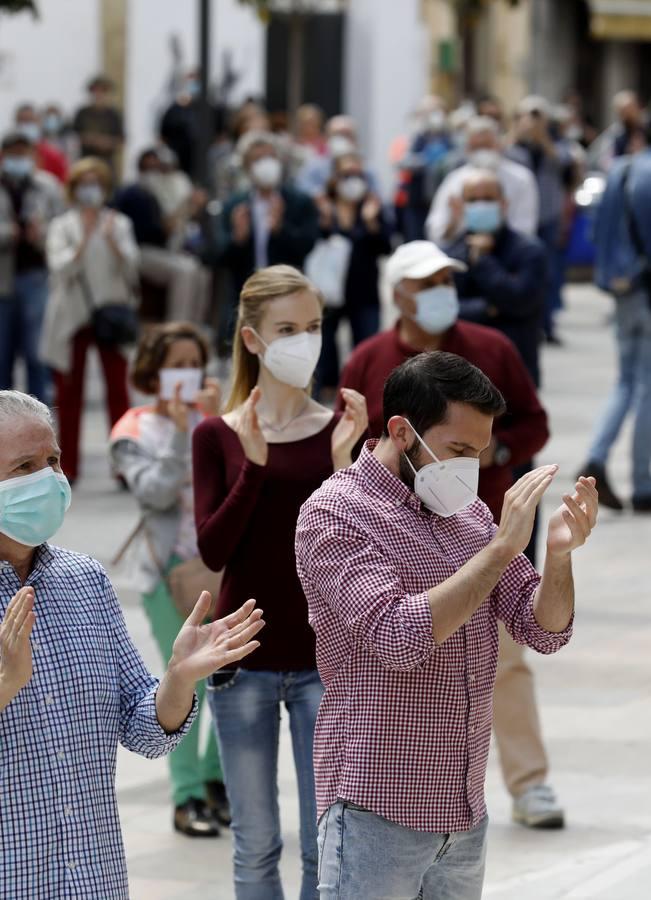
[0,0,100,131]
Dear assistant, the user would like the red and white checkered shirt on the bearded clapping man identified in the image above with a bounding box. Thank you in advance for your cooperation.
[296,441,572,832]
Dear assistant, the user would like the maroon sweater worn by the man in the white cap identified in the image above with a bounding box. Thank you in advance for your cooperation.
[338,322,549,521]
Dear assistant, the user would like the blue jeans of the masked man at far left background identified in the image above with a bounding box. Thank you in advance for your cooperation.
[0,269,51,403]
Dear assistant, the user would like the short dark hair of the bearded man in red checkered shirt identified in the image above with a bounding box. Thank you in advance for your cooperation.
[383,350,506,437]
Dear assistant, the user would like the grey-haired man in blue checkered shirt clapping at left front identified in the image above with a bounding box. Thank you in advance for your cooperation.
[0,391,263,900]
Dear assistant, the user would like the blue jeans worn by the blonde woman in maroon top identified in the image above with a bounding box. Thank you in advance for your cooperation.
[207,669,323,900]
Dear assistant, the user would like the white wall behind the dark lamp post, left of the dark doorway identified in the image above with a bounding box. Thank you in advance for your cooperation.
[126,0,265,172]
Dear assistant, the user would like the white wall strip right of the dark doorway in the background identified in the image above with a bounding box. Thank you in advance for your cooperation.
[344,0,430,193]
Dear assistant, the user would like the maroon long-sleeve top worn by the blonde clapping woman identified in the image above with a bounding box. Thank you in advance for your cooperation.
[192,414,340,672]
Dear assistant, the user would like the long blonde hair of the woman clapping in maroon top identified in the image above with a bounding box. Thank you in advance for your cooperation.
[225,266,323,412]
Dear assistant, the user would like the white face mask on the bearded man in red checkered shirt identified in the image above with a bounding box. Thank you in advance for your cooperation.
[405,419,479,519]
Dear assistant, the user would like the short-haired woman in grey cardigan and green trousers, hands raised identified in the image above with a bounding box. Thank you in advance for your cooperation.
[111,323,230,837]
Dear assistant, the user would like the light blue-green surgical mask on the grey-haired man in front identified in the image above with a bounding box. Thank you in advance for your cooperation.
[0,466,72,547]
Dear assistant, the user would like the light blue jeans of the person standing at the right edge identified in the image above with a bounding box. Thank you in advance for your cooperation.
[588,291,651,499]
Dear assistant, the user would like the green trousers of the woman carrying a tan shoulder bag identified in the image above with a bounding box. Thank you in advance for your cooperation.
[142,557,223,806]
